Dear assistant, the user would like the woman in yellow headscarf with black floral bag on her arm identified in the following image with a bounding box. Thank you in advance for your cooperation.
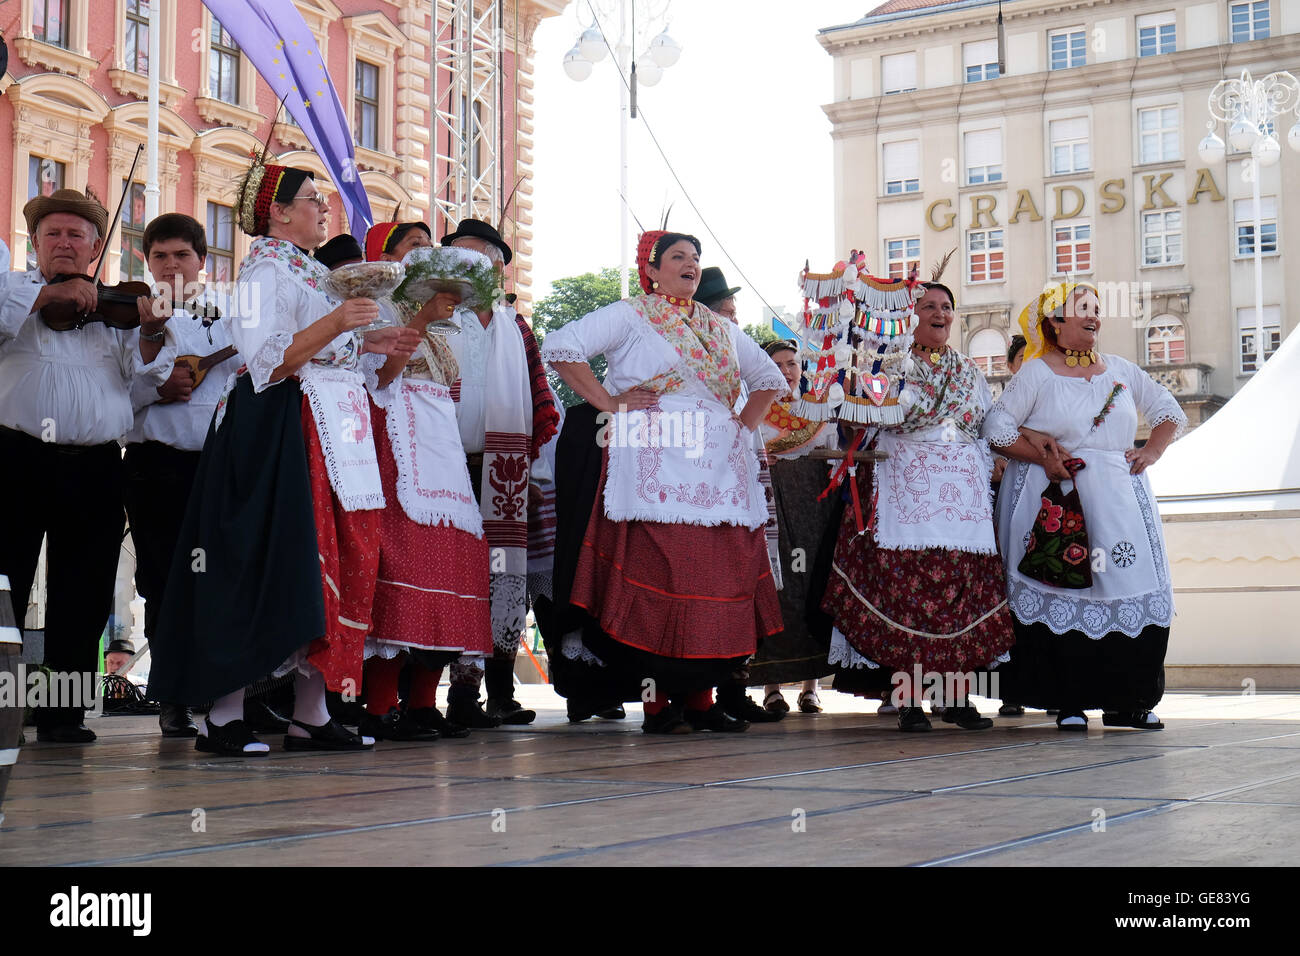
[984,282,1187,731]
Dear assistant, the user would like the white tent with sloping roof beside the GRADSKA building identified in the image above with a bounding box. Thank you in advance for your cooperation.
[1151,332,1300,693]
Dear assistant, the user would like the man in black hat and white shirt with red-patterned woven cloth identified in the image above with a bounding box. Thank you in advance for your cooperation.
[442,219,559,727]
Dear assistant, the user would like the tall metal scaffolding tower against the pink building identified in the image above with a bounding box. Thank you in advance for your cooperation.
[432,0,503,235]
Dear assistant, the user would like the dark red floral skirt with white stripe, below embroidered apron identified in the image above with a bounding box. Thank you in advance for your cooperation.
[822,468,1015,672]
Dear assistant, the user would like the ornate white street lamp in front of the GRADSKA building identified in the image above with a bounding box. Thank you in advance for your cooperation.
[1199,70,1300,372]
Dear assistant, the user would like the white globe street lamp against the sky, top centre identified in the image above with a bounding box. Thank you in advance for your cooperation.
[564,0,681,299]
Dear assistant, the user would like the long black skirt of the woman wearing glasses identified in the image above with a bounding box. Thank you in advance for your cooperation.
[150,375,325,704]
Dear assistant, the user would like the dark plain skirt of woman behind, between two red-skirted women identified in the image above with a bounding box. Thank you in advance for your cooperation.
[748,458,841,687]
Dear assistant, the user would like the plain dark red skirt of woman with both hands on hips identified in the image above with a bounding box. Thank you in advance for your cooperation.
[569,472,783,659]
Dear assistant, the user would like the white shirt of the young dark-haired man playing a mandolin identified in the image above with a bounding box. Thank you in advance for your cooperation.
[126,286,243,451]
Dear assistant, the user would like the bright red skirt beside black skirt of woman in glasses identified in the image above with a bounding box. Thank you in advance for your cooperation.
[303,395,384,693]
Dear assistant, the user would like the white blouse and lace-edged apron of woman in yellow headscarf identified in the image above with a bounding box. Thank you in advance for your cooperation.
[983,355,1187,639]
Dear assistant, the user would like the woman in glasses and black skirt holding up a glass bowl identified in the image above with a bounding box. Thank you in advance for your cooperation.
[151,159,419,754]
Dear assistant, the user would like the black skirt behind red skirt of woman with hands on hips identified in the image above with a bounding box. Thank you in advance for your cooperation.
[533,402,744,708]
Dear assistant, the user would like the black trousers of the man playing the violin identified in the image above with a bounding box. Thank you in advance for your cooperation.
[0,428,125,727]
